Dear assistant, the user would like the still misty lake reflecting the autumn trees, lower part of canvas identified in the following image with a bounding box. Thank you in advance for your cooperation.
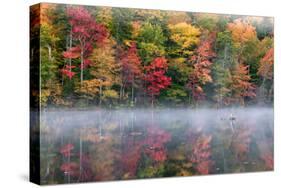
[40,108,274,184]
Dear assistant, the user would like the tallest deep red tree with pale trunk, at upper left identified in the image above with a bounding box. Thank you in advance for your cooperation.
[62,6,107,83]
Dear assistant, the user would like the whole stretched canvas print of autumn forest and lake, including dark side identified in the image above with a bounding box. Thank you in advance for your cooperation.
[30,3,274,184]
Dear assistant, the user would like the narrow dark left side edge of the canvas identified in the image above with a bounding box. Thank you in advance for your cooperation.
[29,3,41,185]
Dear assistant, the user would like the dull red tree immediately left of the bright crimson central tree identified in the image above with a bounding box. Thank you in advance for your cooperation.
[120,42,142,101]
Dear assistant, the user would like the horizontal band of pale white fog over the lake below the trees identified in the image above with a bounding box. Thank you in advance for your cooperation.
[41,108,274,132]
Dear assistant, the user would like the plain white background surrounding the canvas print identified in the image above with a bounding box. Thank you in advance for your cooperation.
[0,0,281,188]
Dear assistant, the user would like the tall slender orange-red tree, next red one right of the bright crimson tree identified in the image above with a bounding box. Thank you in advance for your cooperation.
[187,35,216,100]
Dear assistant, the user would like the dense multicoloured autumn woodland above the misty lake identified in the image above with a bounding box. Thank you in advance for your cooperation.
[31,4,274,108]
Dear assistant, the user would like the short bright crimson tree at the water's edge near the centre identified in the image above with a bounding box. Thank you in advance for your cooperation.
[145,57,171,106]
